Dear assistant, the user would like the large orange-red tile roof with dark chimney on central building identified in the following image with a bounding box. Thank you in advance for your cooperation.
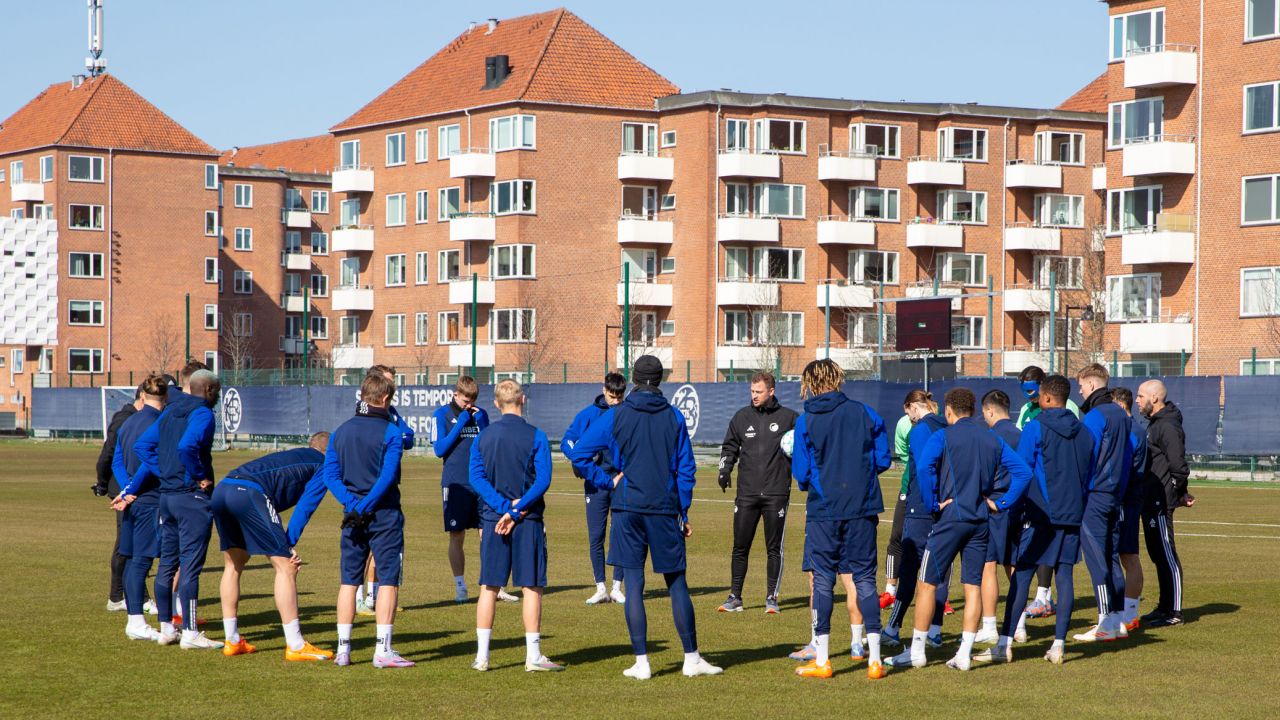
[332,9,680,131]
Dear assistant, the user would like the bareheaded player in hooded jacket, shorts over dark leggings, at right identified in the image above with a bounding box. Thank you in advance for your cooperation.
[974,375,1093,665]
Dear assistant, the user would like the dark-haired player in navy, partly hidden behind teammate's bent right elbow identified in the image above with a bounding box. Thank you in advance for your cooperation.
[974,389,1027,643]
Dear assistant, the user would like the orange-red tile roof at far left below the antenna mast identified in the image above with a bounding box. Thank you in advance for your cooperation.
[0,74,218,155]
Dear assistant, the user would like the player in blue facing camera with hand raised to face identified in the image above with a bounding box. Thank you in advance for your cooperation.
[431,375,489,602]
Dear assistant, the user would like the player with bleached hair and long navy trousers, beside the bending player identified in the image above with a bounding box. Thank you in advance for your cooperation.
[134,370,221,640]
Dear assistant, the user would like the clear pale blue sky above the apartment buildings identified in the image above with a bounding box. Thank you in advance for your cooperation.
[0,0,1107,149]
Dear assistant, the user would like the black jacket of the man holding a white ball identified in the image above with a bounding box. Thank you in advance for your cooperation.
[719,397,799,497]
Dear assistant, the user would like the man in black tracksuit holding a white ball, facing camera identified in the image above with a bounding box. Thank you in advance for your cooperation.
[719,373,797,615]
